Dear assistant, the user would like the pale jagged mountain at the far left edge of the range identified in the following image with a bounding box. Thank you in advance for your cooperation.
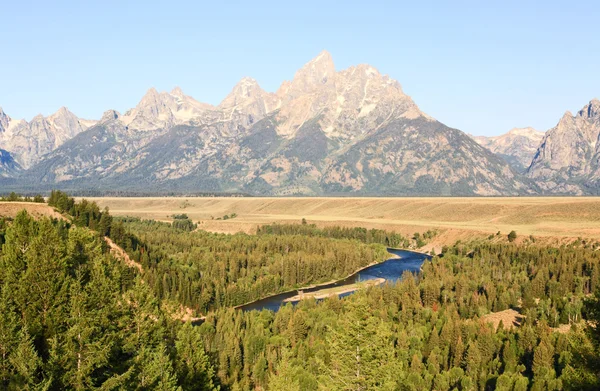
[0,107,95,168]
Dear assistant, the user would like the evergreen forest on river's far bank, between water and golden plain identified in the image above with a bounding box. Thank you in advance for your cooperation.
[111,218,387,313]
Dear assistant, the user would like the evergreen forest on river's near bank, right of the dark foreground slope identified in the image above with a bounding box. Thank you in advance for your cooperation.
[200,243,600,391]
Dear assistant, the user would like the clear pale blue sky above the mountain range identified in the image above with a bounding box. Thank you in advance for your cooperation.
[0,0,600,135]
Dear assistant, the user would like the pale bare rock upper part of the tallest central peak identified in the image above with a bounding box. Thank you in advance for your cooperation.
[277,52,426,142]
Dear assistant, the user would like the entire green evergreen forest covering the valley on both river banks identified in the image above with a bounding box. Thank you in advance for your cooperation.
[0,192,600,391]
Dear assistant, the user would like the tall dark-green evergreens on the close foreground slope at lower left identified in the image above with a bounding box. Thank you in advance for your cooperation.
[0,211,217,390]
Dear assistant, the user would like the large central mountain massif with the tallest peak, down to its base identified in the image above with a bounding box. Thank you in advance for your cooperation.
[25,52,530,195]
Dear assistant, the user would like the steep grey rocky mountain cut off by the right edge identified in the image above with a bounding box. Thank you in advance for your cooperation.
[526,99,600,194]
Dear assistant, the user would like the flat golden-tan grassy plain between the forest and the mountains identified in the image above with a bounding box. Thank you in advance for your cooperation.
[85,197,600,248]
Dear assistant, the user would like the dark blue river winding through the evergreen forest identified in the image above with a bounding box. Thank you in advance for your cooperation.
[238,248,431,311]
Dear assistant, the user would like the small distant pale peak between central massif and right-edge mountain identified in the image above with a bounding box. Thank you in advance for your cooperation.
[473,128,544,173]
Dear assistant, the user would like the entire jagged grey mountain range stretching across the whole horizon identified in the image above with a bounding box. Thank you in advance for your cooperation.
[0,51,600,195]
